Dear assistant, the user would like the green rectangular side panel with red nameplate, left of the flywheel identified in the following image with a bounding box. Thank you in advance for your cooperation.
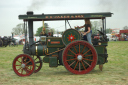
[46,37,64,48]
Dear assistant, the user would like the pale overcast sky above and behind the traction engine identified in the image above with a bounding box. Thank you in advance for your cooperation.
[0,0,128,36]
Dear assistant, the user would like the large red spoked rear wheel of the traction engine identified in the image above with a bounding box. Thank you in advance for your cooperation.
[63,41,97,74]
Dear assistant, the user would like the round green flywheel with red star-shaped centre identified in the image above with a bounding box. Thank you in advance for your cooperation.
[62,29,81,45]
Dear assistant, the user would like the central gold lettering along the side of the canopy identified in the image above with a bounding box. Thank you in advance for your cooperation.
[45,15,84,19]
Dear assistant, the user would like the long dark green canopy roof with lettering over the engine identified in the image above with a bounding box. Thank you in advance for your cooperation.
[19,12,113,21]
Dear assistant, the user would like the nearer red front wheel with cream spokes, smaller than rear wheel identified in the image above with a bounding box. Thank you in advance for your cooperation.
[13,54,35,77]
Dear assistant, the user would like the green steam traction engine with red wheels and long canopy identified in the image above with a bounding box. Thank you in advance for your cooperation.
[12,12,112,76]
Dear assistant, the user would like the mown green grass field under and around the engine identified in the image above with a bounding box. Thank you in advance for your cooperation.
[0,41,128,85]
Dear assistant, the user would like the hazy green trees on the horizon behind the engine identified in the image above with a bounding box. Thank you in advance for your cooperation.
[12,21,128,36]
